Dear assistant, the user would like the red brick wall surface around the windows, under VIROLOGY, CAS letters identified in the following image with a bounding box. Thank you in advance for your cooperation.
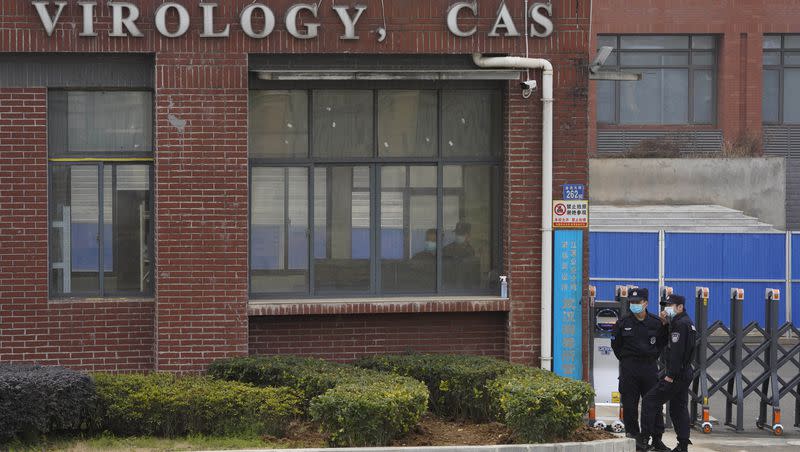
[0,0,596,372]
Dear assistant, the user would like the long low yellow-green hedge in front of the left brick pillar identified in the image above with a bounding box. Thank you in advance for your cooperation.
[94,373,300,436]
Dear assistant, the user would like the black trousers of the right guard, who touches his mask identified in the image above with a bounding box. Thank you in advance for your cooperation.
[642,369,692,442]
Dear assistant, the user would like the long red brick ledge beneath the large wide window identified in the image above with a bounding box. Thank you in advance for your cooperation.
[247,296,511,316]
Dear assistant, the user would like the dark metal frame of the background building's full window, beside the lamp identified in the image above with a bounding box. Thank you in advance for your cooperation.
[597,34,719,127]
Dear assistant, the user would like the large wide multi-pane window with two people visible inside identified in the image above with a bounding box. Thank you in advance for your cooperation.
[249,88,502,297]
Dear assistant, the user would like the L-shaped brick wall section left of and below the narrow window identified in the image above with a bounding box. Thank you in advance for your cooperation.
[0,88,153,372]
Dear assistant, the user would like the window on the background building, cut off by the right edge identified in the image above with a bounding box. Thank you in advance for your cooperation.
[761,35,800,124]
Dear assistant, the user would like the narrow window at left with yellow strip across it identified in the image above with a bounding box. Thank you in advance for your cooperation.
[47,90,153,297]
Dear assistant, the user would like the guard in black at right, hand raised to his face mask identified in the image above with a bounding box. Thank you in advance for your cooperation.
[636,294,697,452]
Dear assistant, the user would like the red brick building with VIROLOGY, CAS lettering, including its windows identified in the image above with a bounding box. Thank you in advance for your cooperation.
[0,0,592,372]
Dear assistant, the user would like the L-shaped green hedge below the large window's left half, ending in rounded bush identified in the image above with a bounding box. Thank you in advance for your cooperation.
[208,356,428,446]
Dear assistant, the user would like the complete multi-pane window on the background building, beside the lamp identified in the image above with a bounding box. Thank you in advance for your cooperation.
[597,35,716,125]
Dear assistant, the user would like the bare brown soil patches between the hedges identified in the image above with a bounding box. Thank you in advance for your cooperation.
[265,413,616,448]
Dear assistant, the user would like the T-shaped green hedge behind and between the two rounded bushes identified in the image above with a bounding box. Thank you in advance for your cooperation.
[356,354,512,421]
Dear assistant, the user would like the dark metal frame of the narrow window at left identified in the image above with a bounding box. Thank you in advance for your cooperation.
[46,87,156,301]
